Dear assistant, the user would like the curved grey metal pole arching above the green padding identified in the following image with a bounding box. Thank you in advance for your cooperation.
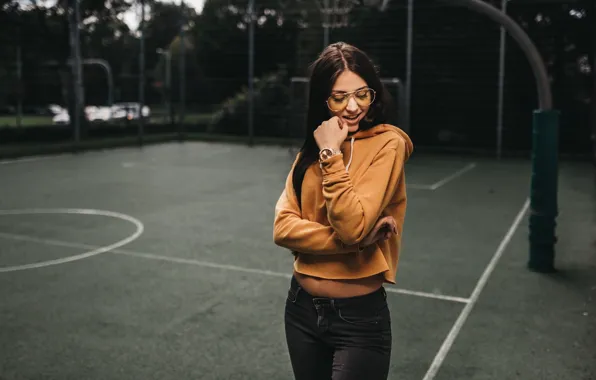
[444,0,553,111]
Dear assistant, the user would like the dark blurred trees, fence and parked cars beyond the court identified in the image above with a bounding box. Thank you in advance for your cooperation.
[0,0,596,157]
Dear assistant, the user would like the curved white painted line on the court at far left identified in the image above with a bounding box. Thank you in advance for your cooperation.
[0,208,145,273]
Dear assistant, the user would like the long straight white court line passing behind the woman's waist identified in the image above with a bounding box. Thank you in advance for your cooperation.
[0,232,469,303]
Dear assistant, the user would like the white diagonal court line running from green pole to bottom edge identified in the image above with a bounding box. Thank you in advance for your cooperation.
[423,199,530,380]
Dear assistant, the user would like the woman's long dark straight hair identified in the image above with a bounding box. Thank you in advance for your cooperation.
[292,42,390,204]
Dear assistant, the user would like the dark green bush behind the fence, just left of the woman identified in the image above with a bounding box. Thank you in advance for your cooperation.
[208,70,290,137]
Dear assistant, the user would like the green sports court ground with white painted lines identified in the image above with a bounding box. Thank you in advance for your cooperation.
[0,143,596,380]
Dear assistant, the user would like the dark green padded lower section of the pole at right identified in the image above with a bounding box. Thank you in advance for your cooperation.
[528,110,559,272]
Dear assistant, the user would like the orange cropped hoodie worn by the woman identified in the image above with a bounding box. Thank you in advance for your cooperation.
[273,124,413,284]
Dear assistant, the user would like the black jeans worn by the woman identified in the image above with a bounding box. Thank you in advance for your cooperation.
[285,277,391,380]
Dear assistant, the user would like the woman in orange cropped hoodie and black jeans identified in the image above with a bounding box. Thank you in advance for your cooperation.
[273,43,412,380]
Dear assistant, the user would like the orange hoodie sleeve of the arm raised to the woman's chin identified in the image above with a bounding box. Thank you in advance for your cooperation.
[321,139,406,245]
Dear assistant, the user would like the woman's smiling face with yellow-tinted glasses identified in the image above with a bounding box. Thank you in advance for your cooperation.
[327,70,374,133]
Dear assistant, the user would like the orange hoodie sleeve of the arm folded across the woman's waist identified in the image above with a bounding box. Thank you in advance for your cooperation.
[273,171,358,255]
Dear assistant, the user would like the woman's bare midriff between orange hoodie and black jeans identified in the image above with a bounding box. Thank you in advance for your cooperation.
[294,272,384,298]
